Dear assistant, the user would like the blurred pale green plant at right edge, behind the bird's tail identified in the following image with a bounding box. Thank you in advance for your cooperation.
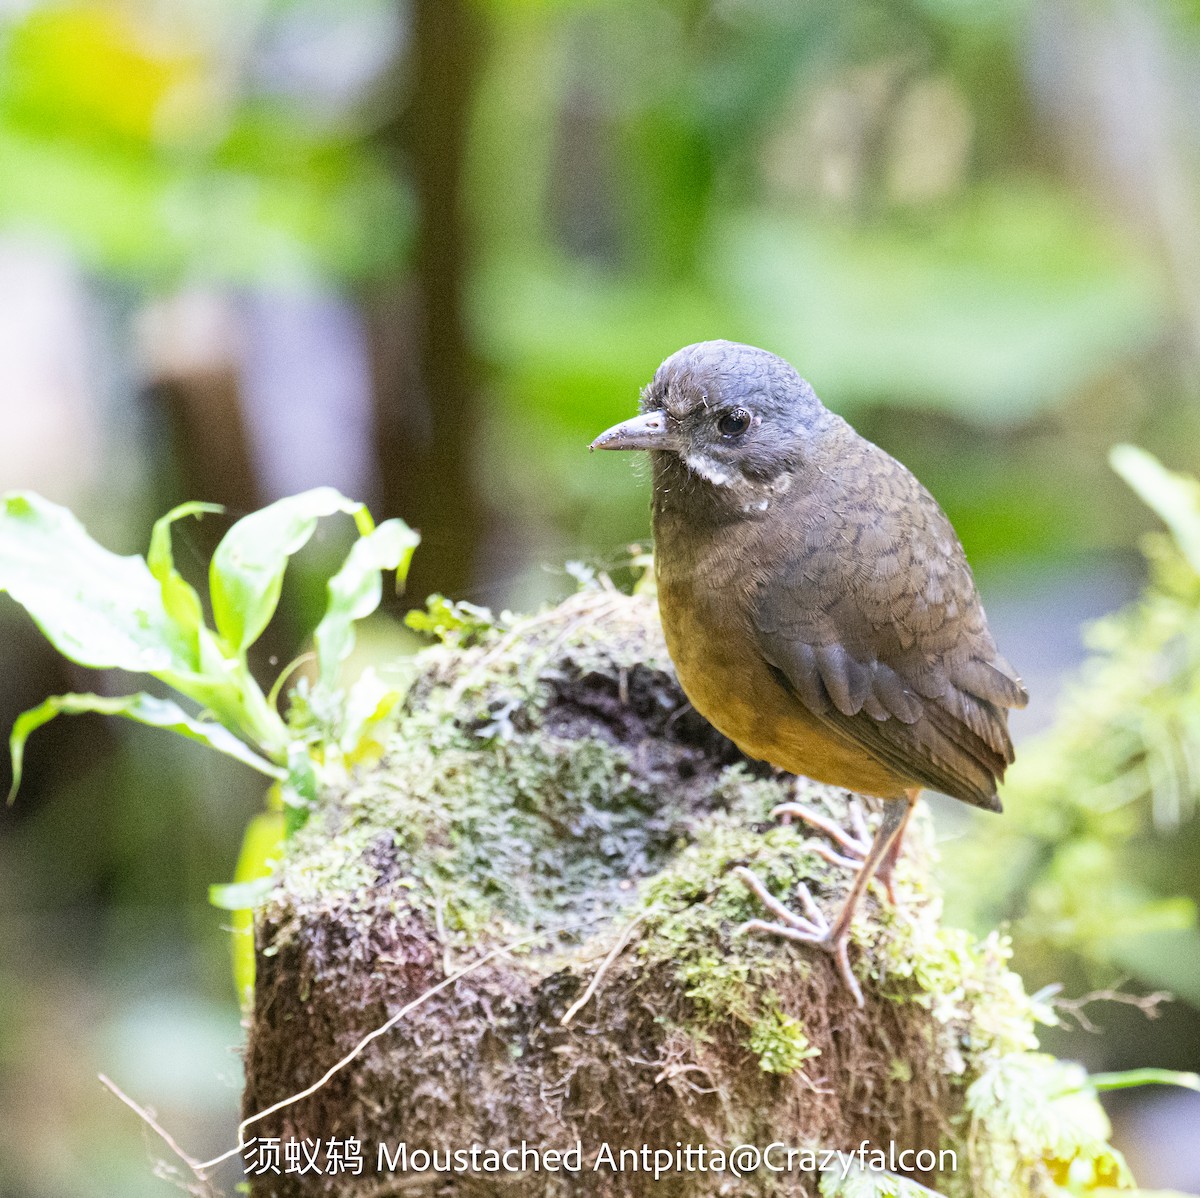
[954,445,1200,1002]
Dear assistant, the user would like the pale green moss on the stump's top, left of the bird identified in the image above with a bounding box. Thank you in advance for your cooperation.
[283,593,715,946]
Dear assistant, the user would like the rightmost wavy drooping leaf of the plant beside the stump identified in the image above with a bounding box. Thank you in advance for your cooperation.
[313,520,421,690]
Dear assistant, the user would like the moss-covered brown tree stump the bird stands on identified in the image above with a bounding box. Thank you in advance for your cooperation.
[244,588,1120,1198]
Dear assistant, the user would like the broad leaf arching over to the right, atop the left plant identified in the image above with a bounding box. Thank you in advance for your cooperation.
[209,486,373,654]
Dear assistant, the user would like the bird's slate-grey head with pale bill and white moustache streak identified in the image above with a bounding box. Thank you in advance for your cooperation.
[592,341,833,498]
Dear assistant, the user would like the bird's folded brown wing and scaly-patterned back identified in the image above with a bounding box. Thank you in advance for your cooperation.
[755,426,1027,810]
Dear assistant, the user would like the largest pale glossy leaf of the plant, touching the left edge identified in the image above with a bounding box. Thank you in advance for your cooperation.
[0,491,191,673]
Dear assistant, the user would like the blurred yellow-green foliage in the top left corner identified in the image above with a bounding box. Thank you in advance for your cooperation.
[0,2,407,280]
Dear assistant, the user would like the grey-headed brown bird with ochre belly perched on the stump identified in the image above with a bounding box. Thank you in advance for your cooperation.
[590,341,1028,1006]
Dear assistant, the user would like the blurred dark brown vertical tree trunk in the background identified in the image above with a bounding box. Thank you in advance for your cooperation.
[368,0,484,598]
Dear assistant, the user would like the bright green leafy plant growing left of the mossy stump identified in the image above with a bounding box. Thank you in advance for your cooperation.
[0,487,419,993]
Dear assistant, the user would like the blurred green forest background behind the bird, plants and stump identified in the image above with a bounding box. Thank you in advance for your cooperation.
[0,0,1200,1198]
